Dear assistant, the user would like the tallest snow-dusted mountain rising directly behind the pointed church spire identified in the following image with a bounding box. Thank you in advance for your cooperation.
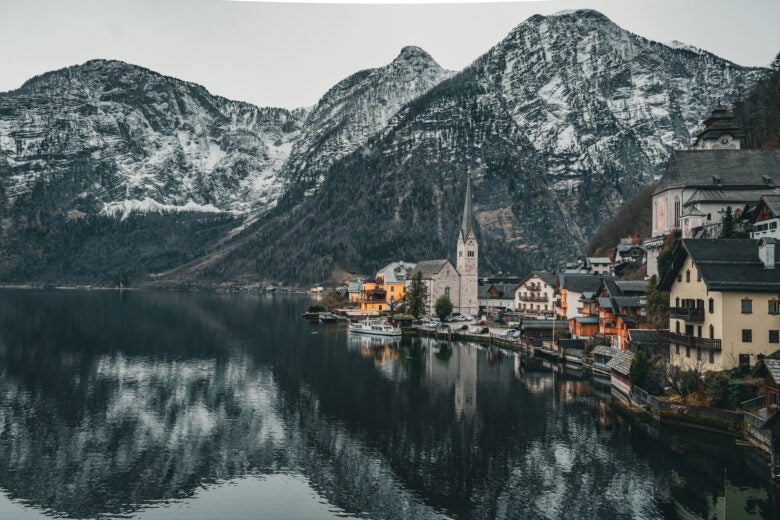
[213,10,766,280]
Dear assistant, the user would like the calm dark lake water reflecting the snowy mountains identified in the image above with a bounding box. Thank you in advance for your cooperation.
[0,291,780,520]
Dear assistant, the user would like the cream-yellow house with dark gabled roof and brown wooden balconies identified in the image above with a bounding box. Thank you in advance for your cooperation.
[661,238,780,370]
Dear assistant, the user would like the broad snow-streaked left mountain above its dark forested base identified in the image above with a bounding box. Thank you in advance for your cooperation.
[0,60,305,219]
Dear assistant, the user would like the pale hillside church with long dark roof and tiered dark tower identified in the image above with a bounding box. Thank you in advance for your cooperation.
[643,102,780,276]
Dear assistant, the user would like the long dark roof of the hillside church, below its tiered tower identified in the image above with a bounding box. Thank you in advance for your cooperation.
[654,149,780,193]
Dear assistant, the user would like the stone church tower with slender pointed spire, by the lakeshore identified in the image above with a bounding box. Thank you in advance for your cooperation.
[453,172,479,316]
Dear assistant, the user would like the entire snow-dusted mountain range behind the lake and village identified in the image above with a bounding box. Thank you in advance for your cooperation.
[0,10,767,282]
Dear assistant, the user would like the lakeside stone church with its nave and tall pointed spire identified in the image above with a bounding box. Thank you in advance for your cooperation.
[414,173,479,316]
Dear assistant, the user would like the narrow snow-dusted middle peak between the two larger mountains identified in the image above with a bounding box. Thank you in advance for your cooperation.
[283,46,454,200]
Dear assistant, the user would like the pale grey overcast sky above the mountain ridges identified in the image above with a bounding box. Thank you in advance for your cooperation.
[0,0,780,108]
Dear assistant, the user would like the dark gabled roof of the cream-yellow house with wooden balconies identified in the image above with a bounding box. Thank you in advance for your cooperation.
[659,238,780,292]
